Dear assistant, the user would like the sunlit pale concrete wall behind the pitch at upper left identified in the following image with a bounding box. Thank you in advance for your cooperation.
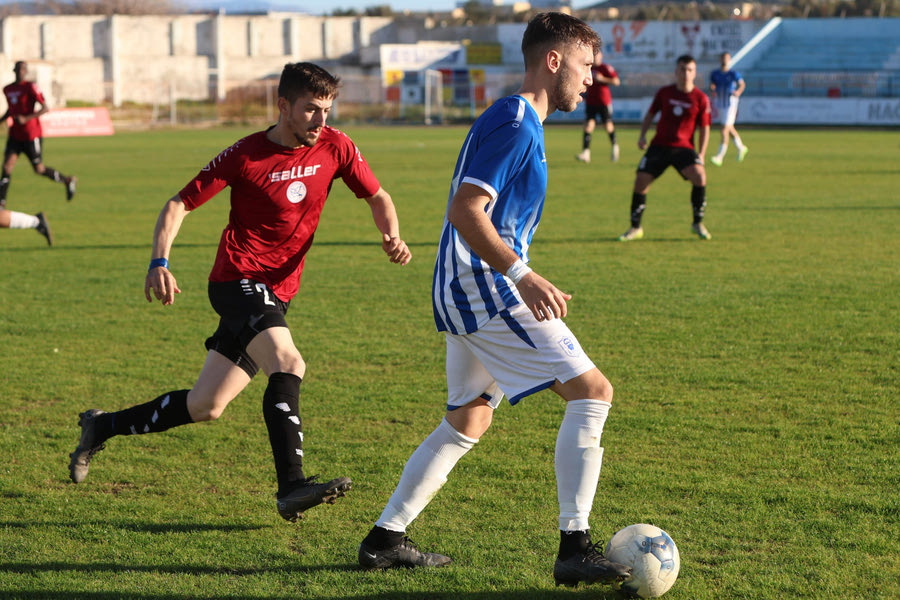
[0,13,393,106]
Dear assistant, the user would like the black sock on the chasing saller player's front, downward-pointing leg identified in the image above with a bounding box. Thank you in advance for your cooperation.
[263,373,306,498]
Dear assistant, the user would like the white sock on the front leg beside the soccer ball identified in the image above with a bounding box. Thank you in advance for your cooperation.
[555,400,611,531]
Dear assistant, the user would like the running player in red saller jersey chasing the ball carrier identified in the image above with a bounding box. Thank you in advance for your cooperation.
[69,63,411,521]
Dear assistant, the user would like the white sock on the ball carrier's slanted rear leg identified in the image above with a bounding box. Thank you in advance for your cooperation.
[375,419,478,531]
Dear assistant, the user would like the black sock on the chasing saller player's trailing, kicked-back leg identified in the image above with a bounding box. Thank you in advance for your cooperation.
[96,390,194,442]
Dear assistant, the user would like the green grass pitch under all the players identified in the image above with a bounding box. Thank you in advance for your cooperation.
[0,124,900,600]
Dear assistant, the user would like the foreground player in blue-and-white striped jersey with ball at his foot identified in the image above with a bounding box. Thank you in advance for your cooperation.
[358,13,629,585]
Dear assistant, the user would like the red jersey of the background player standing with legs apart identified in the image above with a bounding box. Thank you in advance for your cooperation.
[650,84,710,150]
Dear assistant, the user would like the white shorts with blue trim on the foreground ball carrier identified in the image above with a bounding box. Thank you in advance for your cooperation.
[446,304,595,410]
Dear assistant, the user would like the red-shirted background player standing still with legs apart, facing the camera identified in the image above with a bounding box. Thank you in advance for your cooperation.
[619,54,711,242]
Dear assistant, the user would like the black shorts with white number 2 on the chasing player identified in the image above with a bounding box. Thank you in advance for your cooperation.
[206,279,290,379]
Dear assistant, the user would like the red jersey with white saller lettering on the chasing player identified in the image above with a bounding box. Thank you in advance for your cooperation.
[179,126,381,302]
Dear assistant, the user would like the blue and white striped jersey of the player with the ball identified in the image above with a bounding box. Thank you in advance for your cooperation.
[432,96,547,334]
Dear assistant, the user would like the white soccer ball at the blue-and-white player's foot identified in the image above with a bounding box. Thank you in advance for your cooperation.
[606,523,681,598]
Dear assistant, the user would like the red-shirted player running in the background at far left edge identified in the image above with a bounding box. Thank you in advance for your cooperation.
[0,60,76,207]
